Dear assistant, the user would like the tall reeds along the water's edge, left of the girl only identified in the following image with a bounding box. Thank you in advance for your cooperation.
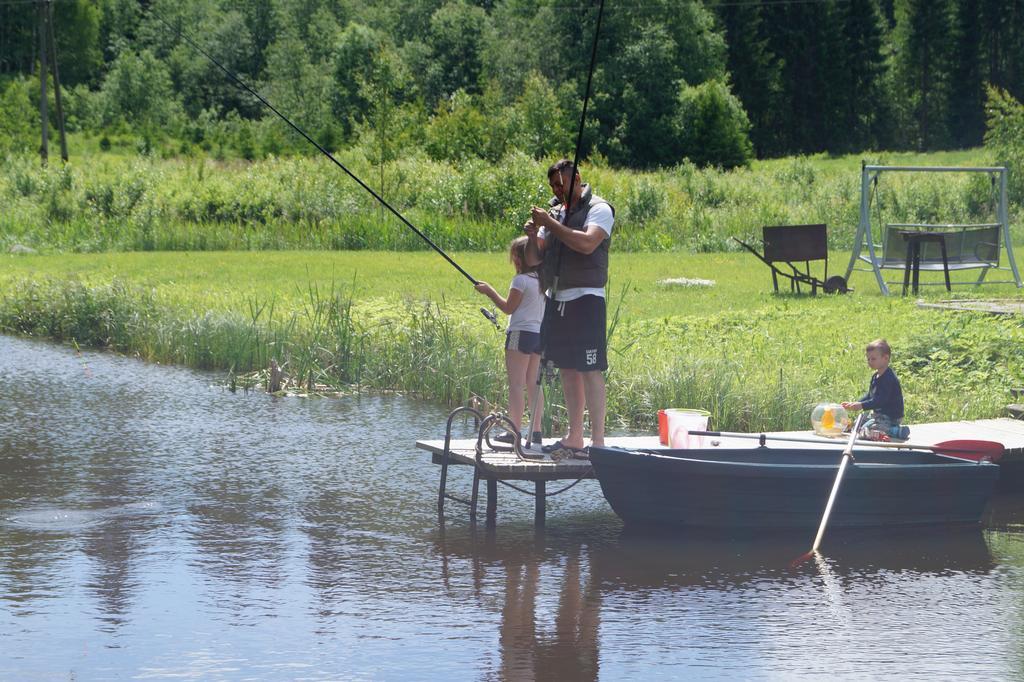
[0,272,505,404]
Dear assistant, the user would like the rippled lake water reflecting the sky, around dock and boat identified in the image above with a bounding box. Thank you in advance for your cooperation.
[0,337,1024,680]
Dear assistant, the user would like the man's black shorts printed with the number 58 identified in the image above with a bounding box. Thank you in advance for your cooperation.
[541,296,608,372]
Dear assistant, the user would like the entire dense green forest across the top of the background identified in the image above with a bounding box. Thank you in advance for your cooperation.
[0,0,1024,168]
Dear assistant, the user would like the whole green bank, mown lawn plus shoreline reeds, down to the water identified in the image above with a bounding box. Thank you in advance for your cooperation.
[0,252,1024,430]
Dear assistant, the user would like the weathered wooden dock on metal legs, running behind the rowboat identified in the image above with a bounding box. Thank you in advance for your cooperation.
[416,418,1024,524]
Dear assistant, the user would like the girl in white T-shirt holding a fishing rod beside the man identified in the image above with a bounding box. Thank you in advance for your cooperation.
[476,237,544,442]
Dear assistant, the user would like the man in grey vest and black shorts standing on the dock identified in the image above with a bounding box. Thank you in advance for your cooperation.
[523,159,615,448]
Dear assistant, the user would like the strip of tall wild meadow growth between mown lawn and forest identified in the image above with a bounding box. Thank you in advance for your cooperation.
[0,150,1024,252]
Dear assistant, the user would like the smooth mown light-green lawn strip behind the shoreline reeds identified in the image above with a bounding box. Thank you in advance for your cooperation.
[0,247,1024,321]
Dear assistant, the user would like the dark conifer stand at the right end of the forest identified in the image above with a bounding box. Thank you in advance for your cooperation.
[717,0,1024,156]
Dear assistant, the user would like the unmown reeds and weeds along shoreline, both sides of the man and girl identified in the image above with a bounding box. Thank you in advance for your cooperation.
[0,272,1024,431]
